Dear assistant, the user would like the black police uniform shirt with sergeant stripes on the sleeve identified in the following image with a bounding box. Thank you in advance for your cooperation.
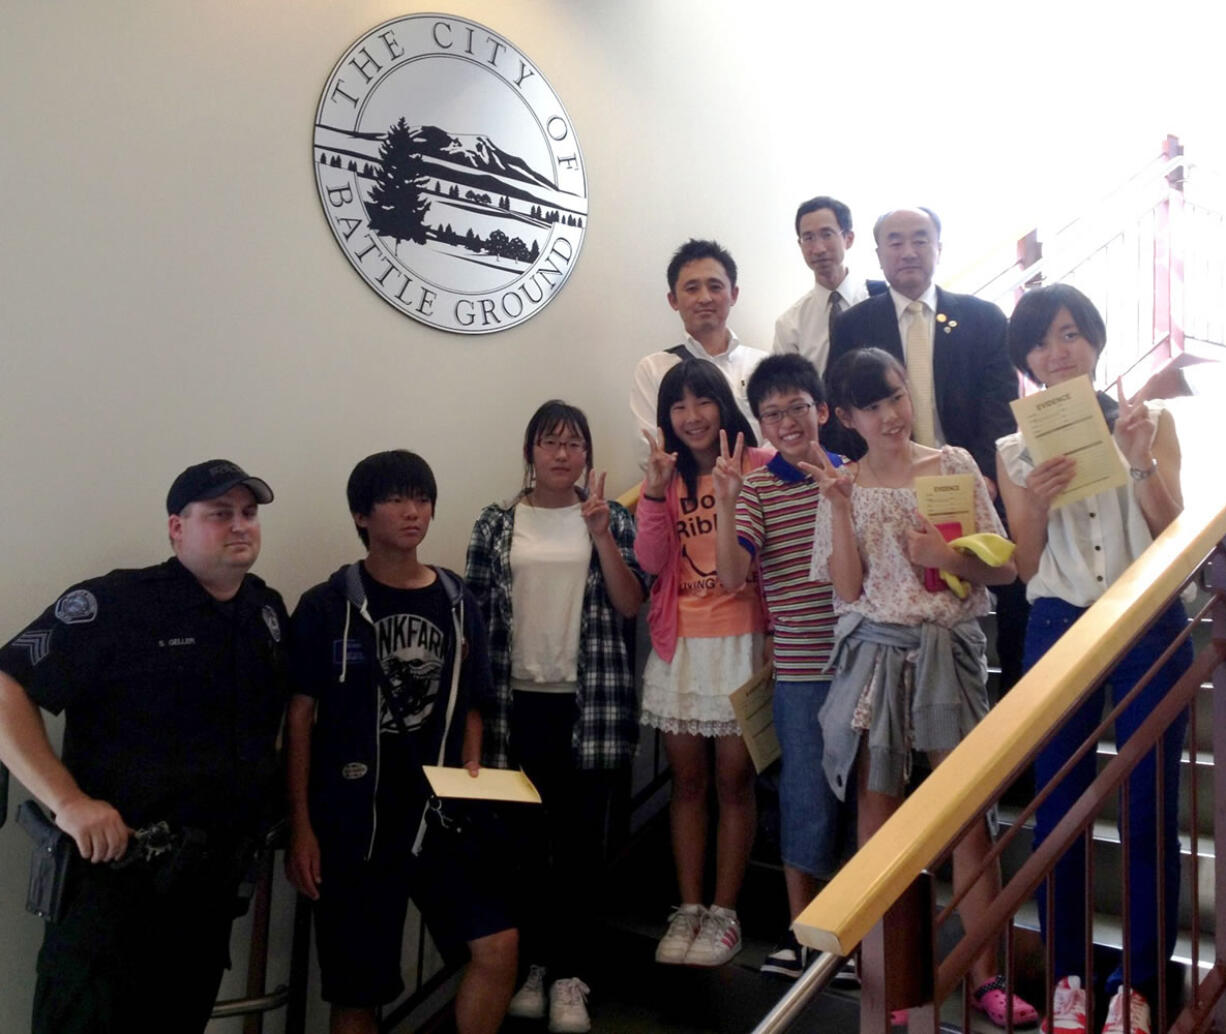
[0,558,289,832]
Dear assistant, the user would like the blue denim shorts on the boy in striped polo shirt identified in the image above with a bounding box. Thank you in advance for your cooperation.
[774,680,853,879]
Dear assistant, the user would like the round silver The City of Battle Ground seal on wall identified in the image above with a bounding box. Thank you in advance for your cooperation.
[313,15,587,334]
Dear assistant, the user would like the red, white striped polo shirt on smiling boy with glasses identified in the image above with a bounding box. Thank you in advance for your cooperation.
[737,451,842,682]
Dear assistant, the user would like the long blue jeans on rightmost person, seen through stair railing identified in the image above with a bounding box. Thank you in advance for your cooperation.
[1024,597,1192,1001]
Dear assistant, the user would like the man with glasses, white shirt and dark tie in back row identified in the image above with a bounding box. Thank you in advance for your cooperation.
[775,195,885,374]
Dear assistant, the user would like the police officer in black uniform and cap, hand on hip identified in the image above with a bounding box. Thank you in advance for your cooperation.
[0,460,289,1034]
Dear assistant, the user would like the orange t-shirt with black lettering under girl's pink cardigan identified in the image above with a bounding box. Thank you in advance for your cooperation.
[677,473,765,639]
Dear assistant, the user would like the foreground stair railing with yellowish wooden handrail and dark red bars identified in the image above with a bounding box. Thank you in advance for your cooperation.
[755,497,1226,1034]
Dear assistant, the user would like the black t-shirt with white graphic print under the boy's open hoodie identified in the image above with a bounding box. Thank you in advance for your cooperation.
[362,567,452,740]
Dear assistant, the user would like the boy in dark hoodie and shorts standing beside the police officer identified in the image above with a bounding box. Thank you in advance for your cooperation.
[286,450,517,1034]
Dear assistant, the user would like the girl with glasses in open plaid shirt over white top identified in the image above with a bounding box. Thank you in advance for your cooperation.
[467,400,646,1030]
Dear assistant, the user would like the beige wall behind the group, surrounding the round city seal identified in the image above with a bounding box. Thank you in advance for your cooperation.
[0,0,1214,1032]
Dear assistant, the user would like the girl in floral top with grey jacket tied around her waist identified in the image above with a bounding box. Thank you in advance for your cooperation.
[802,348,1038,1025]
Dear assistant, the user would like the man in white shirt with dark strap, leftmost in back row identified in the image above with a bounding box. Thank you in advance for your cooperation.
[630,238,766,466]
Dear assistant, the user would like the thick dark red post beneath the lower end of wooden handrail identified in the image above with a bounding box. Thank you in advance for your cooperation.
[859,872,935,1034]
